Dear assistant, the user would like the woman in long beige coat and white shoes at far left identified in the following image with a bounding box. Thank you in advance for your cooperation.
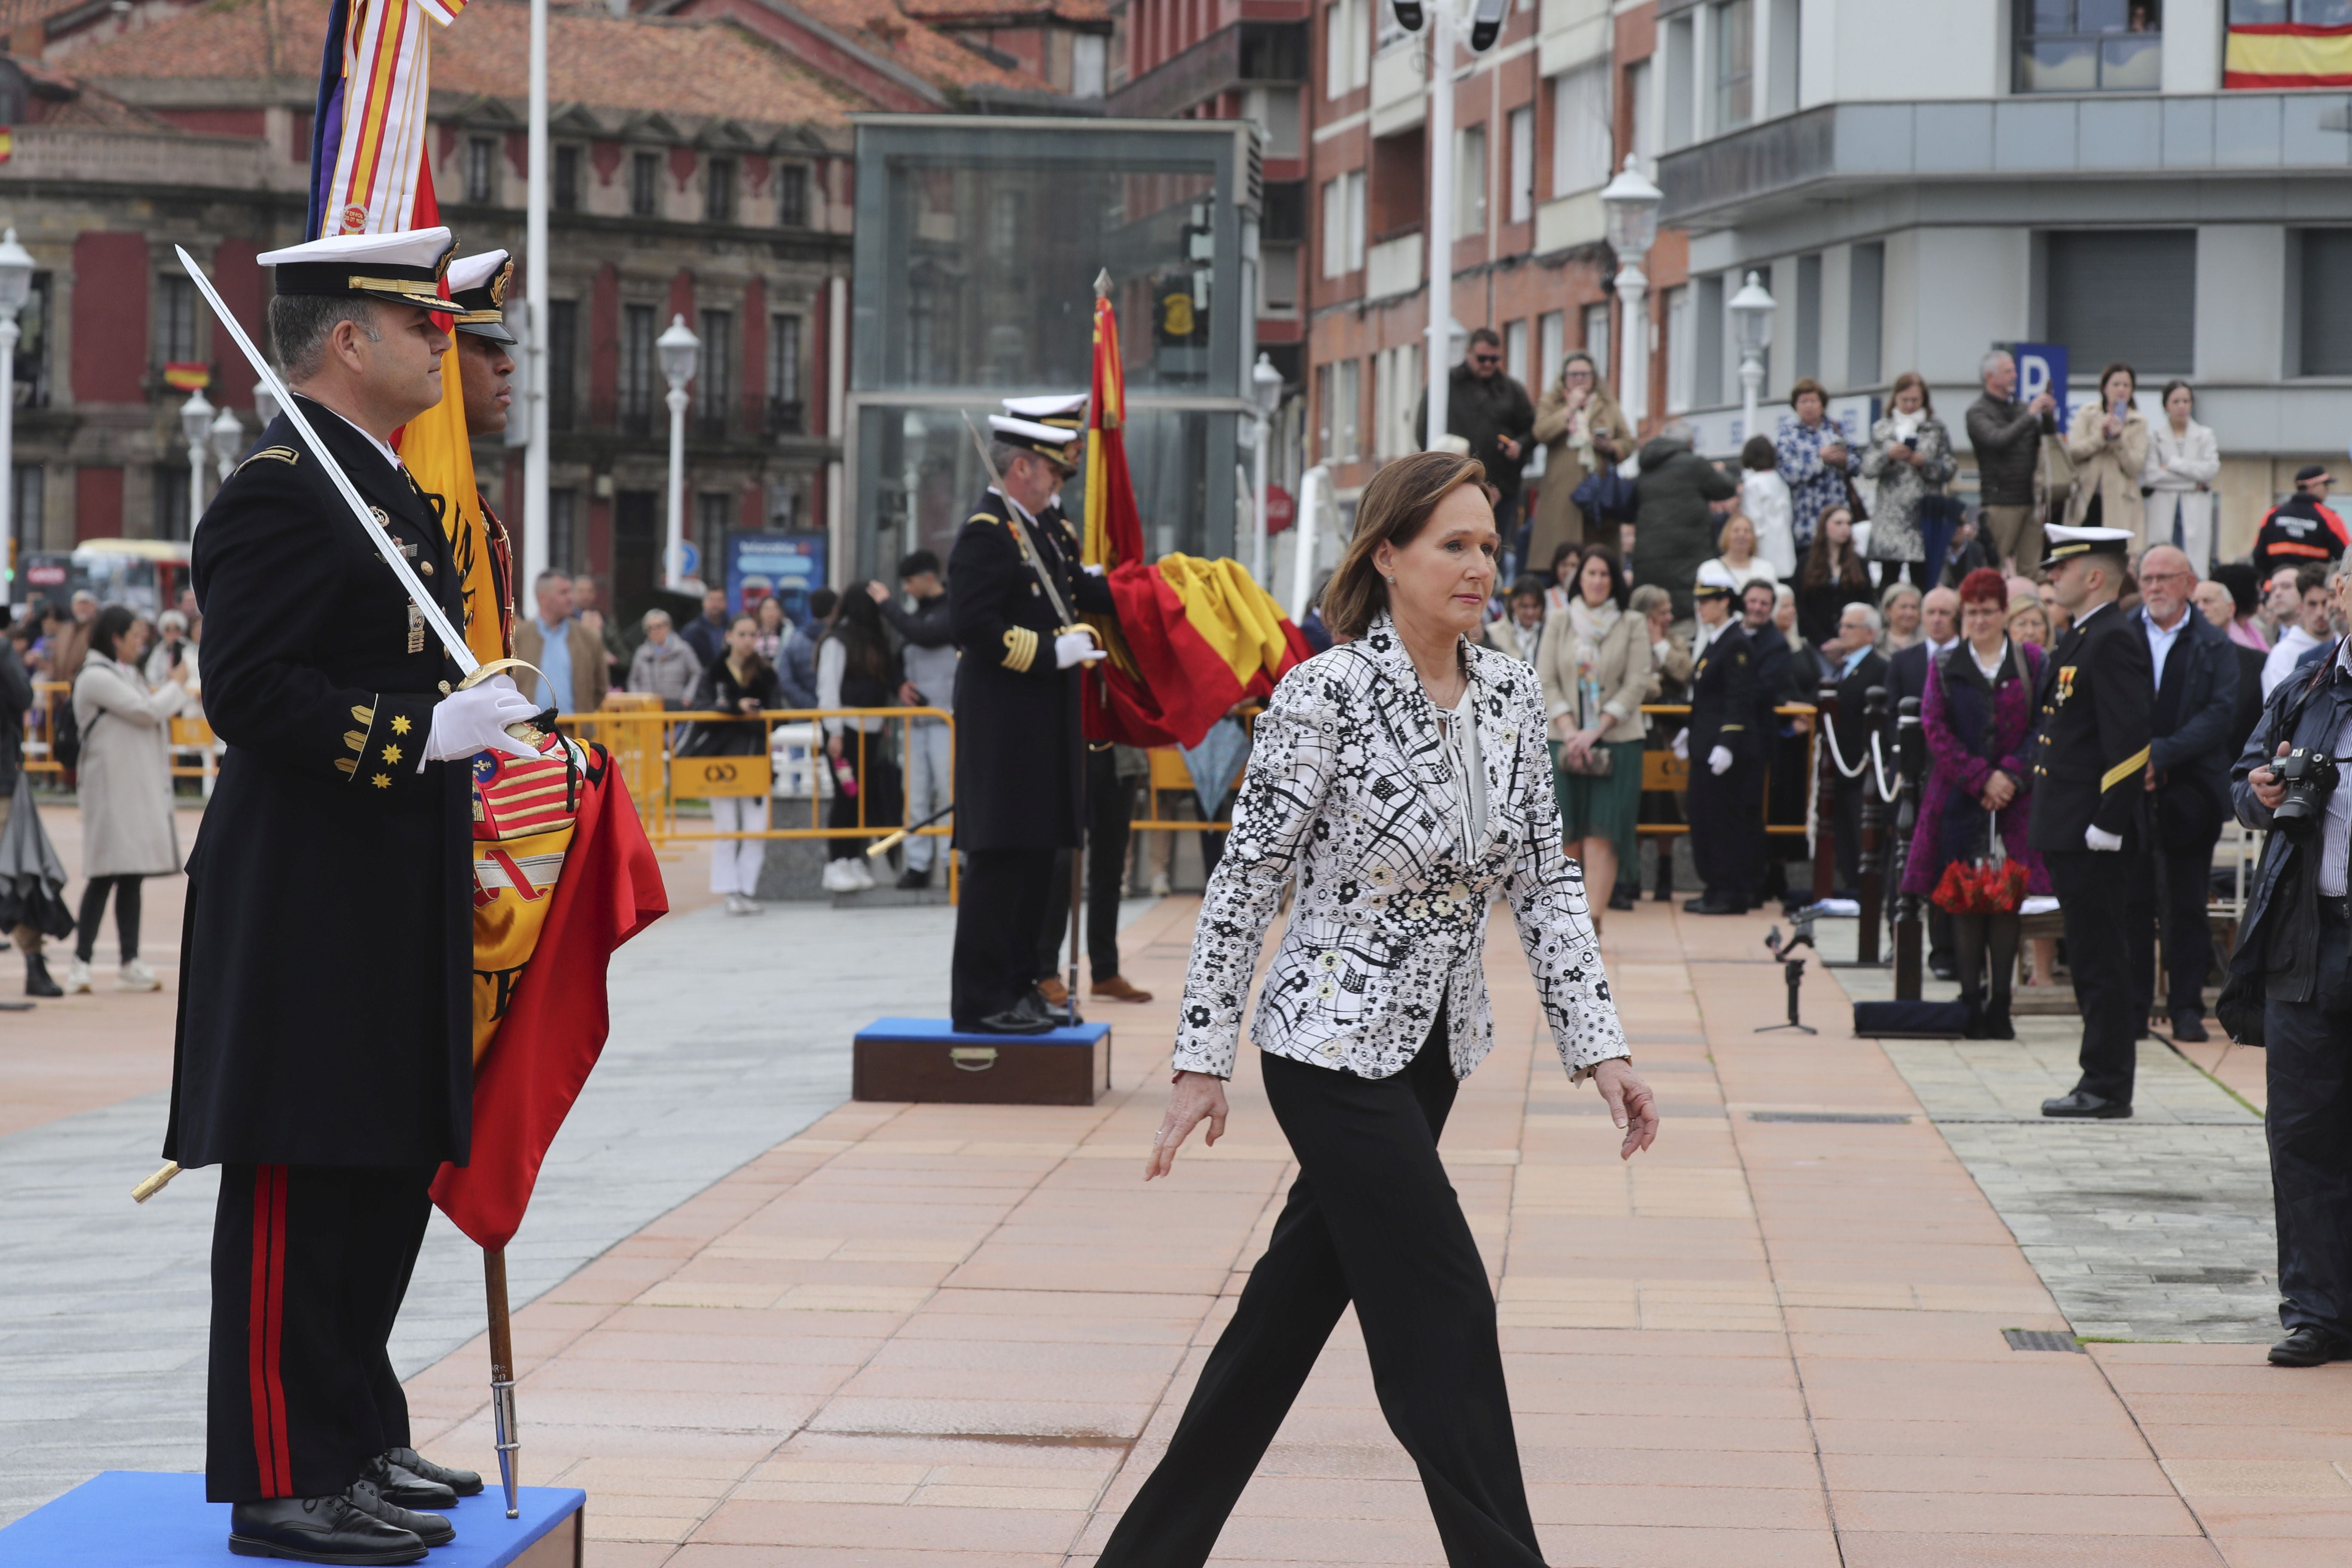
[66,604,188,992]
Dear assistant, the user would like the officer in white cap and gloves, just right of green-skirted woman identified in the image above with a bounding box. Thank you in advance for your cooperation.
[1681,562,1764,915]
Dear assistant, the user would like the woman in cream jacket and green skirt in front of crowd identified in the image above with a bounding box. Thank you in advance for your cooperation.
[1536,543,1675,926]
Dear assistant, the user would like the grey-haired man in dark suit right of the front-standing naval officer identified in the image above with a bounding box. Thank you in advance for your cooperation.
[2128,545,2239,1041]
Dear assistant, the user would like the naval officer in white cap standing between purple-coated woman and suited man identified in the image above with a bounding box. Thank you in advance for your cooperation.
[2030,527,2157,1119]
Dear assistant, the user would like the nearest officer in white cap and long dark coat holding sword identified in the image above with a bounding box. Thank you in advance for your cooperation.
[165,228,534,1563]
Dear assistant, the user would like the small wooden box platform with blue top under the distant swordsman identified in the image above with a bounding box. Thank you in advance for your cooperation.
[849,1018,1110,1105]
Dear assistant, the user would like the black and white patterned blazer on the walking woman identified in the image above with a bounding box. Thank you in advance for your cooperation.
[1176,613,1630,1079]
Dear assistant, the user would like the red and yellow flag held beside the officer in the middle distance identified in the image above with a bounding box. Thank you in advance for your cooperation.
[1084,273,1312,747]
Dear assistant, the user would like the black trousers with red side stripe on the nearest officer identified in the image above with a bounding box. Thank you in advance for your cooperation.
[205,1166,433,1502]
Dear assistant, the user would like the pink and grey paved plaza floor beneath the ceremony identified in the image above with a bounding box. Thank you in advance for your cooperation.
[0,827,2352,1568]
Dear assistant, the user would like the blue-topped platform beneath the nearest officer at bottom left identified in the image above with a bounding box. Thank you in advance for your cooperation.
[0,1469,588,1568]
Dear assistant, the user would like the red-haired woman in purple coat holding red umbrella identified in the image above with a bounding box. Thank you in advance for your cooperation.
[1903,569,2051,1039]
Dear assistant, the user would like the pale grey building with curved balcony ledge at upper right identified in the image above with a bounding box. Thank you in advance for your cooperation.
[1649,0,2352,555]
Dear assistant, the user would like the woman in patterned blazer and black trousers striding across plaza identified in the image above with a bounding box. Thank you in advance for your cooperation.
[1098,451,1658,1568]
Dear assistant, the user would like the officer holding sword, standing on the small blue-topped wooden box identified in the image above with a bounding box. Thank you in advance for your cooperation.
[948,414,1115,1034]
